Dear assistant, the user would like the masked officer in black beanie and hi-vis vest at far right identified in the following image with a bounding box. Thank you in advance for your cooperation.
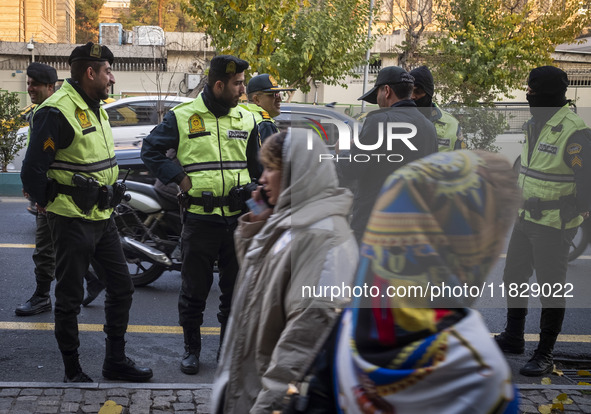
[495,66,591,376]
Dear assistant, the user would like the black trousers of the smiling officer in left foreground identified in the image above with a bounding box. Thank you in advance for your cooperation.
[48,213,133,352]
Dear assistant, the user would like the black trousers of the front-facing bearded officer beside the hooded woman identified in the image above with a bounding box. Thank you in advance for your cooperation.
[179,219,238,330]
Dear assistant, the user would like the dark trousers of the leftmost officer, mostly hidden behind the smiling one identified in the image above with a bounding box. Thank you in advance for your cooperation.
[33,213,100,296]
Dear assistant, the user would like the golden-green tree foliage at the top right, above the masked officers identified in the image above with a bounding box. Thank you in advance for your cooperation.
[424,0,591,105]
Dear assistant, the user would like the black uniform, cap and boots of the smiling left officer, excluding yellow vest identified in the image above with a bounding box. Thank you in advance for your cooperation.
[21,42,152,382]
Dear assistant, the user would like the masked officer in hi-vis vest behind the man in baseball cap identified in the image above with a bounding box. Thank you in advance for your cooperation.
[410,66,466,152]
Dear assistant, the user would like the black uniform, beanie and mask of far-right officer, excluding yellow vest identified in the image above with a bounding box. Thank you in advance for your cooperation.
[495,67,591,376]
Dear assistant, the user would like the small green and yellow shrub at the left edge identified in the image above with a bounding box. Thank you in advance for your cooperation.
[0,91,26,172]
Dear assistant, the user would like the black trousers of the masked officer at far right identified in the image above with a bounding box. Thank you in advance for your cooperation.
[503,219,577,345]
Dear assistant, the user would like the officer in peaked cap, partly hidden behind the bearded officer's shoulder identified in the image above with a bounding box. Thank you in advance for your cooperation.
[241,73,295,142]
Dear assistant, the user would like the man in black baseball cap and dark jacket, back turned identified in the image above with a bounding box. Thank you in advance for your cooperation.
[337,66,437,242]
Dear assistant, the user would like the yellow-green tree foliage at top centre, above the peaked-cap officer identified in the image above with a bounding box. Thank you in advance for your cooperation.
[188,0,375,92]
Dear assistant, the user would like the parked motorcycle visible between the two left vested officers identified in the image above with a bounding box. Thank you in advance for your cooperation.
[115,181,182,286]
